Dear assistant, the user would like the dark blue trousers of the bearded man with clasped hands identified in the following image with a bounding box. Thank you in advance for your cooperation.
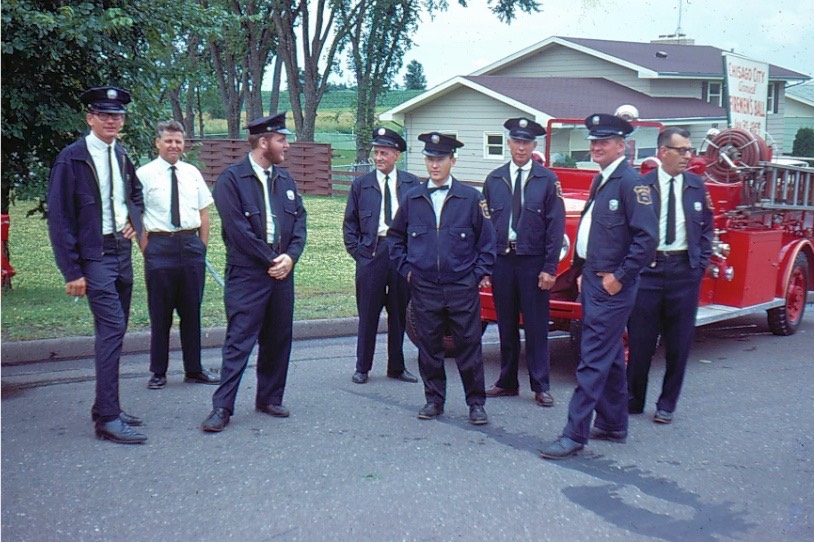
[212,265,294,413]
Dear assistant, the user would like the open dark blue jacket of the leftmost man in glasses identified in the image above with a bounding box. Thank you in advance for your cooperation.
[47,137,144,282]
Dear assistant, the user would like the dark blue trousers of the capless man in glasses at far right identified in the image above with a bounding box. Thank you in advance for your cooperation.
[627,255,704,412]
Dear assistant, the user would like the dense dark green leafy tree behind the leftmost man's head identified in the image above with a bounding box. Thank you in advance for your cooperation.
[2,0,210,212]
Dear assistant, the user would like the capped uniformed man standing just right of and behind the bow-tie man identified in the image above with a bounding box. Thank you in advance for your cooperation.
[483,117,565,407]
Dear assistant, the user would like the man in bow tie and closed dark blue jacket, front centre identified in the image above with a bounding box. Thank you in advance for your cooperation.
[387,132,495,425]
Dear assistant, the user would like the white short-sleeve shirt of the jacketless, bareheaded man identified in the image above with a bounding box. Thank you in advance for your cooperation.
[136,157,212,232]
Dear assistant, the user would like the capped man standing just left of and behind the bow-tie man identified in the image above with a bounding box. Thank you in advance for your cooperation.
[342,128,419,384]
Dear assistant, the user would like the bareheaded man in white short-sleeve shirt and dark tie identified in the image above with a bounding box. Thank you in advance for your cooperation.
[136,121,220,389]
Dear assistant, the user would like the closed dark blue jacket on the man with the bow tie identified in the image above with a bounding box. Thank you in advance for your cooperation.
[387,178,495,284]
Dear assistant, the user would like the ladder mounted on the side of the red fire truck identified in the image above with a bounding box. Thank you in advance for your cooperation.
[754,162,814,211]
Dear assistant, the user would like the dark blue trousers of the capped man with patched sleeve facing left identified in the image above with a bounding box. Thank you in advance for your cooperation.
[563,267,638,444]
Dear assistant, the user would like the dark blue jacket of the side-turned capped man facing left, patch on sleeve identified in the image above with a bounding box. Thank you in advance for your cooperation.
[574,161,659,284]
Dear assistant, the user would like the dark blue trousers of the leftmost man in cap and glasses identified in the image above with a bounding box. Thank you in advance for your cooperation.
[82,234,133,422]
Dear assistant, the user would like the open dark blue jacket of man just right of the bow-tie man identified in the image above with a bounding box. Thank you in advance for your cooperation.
[483,162,565,275]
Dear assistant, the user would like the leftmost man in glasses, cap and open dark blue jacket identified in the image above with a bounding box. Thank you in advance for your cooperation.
[47,87,147,444]
